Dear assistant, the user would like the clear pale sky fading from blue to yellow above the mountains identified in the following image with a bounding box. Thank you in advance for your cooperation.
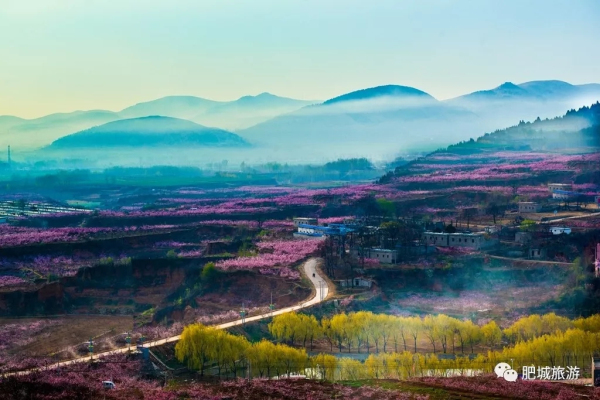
[0,0,600,117]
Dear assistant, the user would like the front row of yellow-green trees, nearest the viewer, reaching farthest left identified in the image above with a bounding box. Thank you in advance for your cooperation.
[175,324,600,381]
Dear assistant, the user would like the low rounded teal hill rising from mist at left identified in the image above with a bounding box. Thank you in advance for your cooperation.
[49,116,248,150]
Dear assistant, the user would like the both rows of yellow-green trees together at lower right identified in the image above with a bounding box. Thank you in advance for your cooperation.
[175,311,600,380]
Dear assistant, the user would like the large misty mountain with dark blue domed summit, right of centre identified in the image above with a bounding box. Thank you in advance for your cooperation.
[238,85,472,158]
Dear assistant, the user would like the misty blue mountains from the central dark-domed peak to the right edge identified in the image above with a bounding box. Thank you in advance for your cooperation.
[238,81,600,157]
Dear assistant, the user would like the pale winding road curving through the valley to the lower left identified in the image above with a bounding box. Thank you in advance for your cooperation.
[5,258,329,376]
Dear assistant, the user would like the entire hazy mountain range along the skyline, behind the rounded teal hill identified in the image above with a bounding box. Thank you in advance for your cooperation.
[0,81,600,161]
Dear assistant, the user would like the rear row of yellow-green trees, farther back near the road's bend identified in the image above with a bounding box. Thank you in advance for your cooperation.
[269,311,600,354]
